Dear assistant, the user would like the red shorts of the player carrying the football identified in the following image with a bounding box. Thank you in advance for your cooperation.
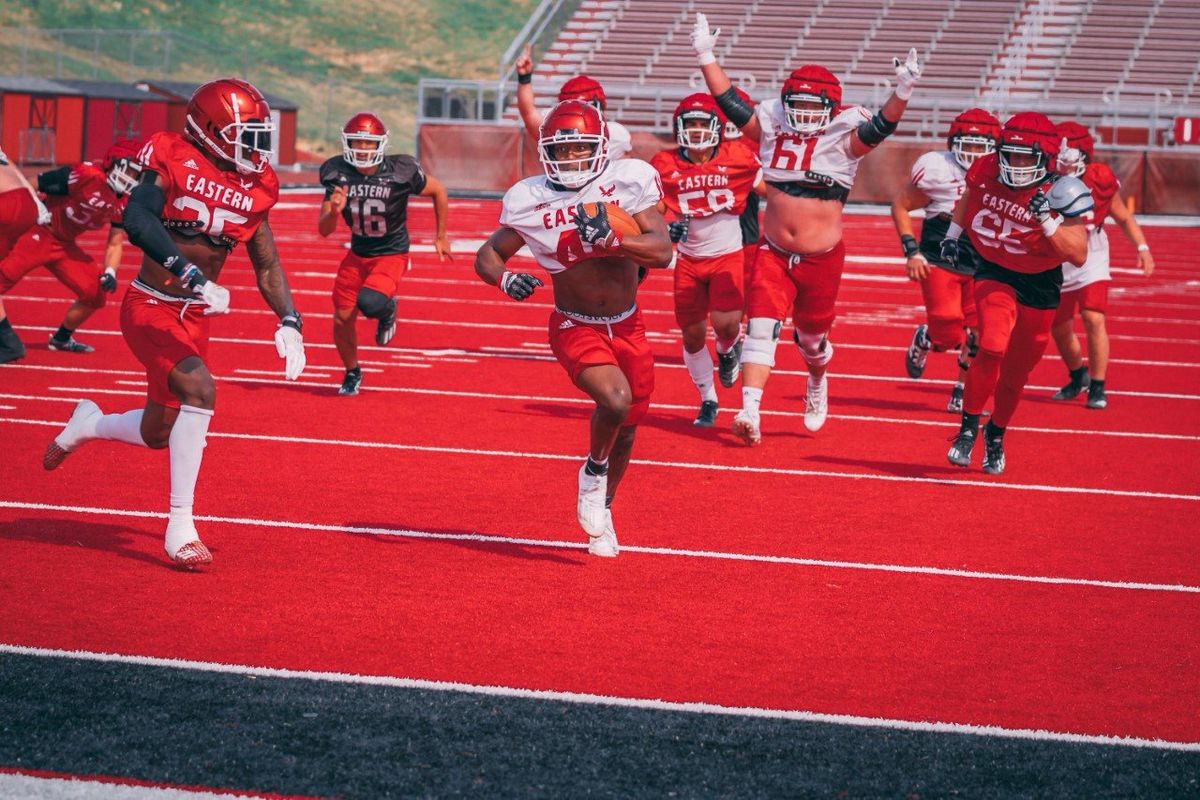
[548,308,654,427]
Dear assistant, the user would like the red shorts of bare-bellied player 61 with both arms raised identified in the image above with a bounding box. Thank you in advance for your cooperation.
[746,241,846,333]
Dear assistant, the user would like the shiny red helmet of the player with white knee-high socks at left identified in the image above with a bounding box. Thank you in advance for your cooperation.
[186,78,275,175]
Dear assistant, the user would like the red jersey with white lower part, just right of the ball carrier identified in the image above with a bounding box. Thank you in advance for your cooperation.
[650,140,762,258]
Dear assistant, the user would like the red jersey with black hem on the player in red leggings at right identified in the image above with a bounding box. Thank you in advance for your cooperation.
[964,154,1062,273]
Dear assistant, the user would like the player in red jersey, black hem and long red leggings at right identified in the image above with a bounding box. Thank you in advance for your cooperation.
[941,112,1092,475]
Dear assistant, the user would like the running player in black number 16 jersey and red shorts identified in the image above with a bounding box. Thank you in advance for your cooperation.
[317,112,454,395]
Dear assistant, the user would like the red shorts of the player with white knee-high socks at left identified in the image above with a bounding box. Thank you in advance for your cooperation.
[121,284,209,408]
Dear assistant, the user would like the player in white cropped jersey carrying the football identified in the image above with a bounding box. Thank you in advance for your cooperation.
[475,100,672,557]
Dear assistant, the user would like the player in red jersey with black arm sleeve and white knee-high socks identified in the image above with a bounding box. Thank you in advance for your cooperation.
[42,78,305,567]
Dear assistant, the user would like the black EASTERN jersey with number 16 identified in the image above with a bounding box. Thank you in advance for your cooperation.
[320,155,425,258]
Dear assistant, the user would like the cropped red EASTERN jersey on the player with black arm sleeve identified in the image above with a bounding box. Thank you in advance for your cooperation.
[138,131,280,249]
